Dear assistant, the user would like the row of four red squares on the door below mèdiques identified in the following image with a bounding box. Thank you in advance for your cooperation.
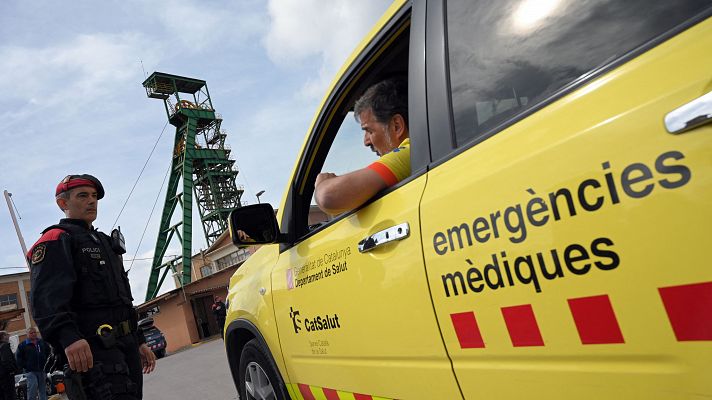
[450,282,712,349]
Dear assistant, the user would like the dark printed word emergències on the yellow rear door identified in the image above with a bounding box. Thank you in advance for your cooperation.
[433,151,692,256]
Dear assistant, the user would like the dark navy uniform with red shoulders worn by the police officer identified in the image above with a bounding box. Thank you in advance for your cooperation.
[28,218,145,399]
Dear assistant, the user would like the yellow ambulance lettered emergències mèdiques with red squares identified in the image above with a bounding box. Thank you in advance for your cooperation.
[225,0,712,400]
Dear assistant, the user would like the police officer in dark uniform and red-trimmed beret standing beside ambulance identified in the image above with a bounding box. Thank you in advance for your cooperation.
[27,175,156,400]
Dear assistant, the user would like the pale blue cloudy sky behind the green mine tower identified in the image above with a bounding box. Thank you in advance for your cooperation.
[0,0,390,303]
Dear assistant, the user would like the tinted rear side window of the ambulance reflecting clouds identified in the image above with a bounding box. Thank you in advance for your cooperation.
[446,0,712,146]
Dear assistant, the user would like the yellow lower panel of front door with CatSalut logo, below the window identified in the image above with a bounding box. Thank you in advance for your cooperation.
[273,176,460,399]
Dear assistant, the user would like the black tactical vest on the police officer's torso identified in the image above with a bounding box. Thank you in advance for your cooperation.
[42,223,133,312]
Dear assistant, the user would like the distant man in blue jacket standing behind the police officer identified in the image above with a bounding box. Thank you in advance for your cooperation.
[16,327,51,400]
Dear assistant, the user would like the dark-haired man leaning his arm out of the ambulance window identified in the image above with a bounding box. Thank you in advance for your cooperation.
[314,79,410,215]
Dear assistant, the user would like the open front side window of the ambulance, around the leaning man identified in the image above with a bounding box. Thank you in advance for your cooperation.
[285,18,410,240]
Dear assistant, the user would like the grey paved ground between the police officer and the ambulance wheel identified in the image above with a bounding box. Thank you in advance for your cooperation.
[143,339,237,400]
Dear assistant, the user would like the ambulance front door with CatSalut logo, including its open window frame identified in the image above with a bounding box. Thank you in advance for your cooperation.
[272,6,461,399]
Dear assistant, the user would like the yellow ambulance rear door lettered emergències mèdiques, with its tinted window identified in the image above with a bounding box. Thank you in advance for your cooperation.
[421,0,712,400]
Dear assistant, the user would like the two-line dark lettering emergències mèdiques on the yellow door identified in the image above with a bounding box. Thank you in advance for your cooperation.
[433,151,692,297]
